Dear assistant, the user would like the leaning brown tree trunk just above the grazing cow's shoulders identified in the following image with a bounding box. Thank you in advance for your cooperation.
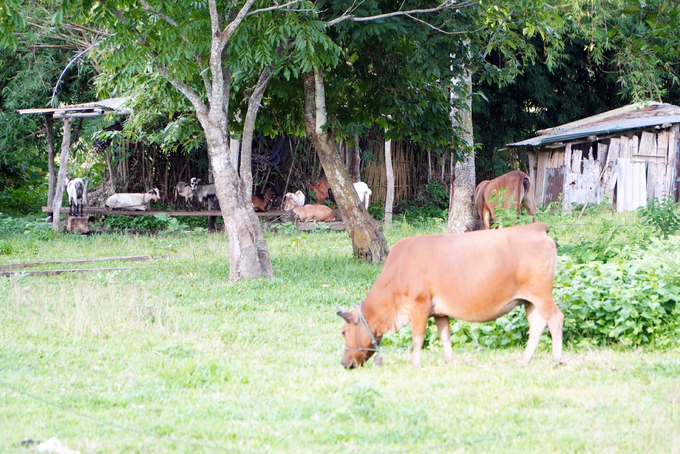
[305,70,389,262]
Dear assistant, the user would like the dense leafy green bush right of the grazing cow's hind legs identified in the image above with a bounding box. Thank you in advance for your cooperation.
[555,254,680,345]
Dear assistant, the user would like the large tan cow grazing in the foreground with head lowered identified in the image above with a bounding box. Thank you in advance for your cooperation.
[338,223,564,368]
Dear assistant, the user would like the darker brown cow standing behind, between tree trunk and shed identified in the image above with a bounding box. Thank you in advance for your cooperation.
[473,170,536,230]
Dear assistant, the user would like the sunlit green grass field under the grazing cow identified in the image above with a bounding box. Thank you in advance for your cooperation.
[0,217,680,453]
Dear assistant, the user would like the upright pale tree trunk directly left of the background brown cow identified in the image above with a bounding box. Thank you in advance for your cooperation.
[448,71,475,233]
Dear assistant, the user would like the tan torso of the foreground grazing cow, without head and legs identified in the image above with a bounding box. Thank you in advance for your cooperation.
[367,223,557,321]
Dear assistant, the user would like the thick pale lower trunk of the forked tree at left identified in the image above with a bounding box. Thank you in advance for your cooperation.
[199,117,274,280]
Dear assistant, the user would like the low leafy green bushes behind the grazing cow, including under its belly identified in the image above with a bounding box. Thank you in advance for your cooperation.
[384,227,680,348]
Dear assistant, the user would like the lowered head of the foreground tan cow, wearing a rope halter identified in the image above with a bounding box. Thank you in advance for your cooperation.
[338,303,380,369]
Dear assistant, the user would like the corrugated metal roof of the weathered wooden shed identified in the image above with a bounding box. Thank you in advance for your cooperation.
[508,103,680,147]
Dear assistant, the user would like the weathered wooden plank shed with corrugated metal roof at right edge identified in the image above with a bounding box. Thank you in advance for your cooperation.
[508,102,680,212]
